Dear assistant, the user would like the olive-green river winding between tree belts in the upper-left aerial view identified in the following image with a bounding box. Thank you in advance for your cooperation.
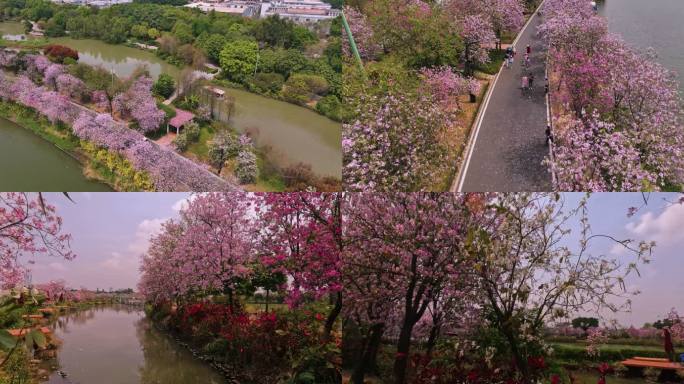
[0,22,342,178]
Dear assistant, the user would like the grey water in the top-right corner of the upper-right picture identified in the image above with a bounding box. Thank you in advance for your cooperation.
[599,0,684,92]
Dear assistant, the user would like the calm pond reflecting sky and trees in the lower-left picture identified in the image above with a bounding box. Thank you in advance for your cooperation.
[47,306,224,384]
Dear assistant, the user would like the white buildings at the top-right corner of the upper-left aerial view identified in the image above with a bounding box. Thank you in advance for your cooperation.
[260,0,341,24]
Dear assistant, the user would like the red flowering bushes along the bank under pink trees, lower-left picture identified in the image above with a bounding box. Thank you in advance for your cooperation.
[169,303,340,383]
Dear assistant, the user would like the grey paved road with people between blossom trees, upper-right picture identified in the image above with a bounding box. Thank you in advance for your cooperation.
[455,9,552,192]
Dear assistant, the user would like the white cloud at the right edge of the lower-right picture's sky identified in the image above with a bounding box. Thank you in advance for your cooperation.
[626,204,684,248]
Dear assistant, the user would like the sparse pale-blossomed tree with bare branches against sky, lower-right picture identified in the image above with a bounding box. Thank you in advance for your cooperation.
[467,193,655,384]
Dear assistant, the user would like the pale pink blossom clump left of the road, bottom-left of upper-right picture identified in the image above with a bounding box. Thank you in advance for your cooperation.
[342,91,455,190]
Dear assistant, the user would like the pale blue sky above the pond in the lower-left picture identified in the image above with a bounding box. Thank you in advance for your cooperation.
[32,193,189,289]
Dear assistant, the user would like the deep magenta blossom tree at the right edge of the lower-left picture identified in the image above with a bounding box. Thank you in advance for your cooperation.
[256,192,342,338]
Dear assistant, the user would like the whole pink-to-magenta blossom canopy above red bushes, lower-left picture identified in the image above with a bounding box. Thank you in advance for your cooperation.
[139,193,342,314]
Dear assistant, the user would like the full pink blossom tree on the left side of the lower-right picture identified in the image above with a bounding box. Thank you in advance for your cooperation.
[343,193,478,384]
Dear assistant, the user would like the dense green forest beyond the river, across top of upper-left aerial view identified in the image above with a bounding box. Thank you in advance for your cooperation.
[0,0,342,121]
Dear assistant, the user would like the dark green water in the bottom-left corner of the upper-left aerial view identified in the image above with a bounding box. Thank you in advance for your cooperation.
[0,118,111,191]
